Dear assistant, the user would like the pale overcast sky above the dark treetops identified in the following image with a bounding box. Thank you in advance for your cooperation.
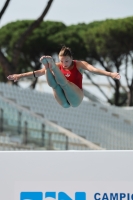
[0,0,133,26]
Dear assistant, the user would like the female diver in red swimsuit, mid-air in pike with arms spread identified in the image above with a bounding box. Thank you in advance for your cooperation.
[7,46,120,108]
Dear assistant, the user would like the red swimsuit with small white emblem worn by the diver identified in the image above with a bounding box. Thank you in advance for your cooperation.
[60,60,82,89]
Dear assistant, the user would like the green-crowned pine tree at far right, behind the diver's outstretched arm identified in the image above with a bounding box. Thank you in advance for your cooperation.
[83,17,133,106]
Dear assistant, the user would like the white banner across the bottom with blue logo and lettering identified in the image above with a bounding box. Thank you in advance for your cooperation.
[0,151,133,200]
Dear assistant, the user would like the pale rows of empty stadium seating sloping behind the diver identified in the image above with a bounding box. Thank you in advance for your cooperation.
[0,83,133,150]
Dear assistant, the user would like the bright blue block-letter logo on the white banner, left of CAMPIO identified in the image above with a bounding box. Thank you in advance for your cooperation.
[20,192,86,200]
